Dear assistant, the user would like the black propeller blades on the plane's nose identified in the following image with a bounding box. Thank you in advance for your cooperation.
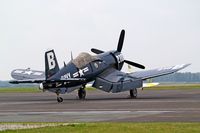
[91,30,145,69]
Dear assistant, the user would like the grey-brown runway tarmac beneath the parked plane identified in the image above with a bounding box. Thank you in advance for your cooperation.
[0,89,200,122]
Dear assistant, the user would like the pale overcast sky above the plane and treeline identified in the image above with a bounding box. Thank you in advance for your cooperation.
[0,0,200,80]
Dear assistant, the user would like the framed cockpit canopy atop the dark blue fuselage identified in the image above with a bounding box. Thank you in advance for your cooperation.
[72,52,98,68]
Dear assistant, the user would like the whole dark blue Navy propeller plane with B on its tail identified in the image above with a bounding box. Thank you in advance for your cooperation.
[10,30,190,102]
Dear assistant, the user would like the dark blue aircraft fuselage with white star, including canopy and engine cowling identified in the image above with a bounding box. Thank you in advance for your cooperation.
[44,51,123,89]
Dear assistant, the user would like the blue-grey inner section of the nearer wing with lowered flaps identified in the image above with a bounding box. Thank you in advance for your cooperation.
[93,68,143,93]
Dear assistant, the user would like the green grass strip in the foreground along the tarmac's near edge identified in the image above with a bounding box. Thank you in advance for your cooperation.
[1,122,200,133]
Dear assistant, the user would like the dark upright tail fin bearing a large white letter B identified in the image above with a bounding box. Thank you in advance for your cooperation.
[45,50,59,79]
